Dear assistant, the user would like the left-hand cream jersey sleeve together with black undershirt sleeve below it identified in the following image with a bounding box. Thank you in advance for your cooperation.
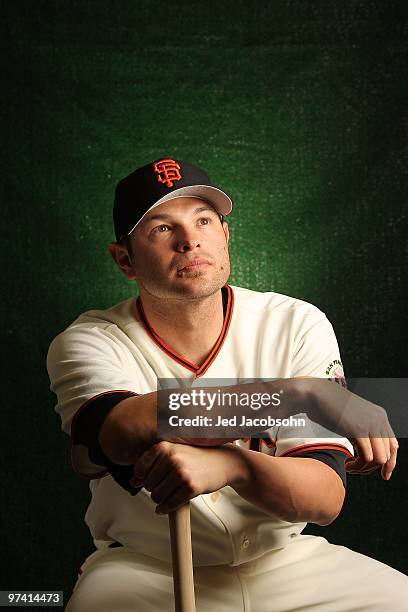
[47,324,140,484]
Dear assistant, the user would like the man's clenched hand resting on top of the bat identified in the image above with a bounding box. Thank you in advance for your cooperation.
[130,441,245,514]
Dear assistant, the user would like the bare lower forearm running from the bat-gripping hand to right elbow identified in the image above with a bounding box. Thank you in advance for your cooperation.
[226,444,345,525]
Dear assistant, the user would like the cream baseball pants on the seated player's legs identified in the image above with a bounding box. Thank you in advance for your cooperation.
[66,535,408,612]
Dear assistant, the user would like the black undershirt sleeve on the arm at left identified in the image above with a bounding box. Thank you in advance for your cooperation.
[71,391,143,495]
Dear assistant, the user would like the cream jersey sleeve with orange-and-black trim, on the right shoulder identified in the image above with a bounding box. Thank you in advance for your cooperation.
[275,307,354,471]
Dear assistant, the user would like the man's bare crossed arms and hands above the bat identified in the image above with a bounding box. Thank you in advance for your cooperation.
[98,378,398,525]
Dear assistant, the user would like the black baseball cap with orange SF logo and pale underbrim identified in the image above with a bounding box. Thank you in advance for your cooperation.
[113,157,232,242]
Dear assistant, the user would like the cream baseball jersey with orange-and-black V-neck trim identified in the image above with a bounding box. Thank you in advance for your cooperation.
[47,286,353,566]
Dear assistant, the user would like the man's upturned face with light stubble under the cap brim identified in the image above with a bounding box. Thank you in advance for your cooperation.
[126,197,230,299]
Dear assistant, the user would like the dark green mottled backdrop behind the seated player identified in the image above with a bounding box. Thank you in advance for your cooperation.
[0,0,408,604]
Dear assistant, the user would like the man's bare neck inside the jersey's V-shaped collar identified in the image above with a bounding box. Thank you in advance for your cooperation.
[140,290,224,365]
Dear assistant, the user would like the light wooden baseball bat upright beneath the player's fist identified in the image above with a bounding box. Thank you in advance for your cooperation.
[169,502,196,612]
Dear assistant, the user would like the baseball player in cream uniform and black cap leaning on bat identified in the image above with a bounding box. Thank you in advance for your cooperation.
[47,158,408,612]
